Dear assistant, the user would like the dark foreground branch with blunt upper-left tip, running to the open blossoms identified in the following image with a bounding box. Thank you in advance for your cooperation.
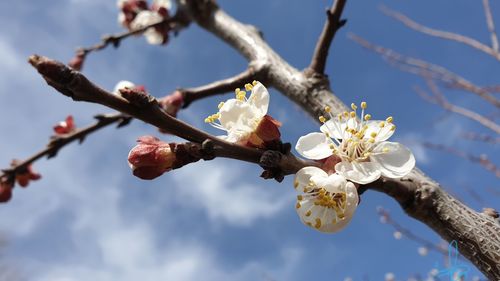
[29,55,318,175]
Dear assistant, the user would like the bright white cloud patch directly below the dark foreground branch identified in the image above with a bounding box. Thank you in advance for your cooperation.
[174,160,293,226]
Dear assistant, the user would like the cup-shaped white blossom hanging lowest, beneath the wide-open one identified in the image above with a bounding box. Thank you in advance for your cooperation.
[294,167,359,233]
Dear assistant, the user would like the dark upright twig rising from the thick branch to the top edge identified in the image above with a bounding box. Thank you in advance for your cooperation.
[308,0,347,74]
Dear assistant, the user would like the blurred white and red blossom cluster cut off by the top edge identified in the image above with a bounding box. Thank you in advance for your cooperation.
[117,0,172,45]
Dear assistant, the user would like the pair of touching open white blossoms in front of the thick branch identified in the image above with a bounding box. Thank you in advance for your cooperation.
[294,102,415,233]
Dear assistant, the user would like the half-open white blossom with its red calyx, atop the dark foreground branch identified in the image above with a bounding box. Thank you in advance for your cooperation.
[205,81,281,148]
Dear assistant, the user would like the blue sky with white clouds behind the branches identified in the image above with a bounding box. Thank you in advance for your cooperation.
[0,0,500,281]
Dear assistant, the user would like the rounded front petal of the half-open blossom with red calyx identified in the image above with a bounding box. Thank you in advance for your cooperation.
[219,99,255,131]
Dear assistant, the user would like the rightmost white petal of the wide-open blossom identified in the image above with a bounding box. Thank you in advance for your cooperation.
[370,142,415,178]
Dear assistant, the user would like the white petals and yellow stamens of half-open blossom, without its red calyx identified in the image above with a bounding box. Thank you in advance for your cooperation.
[205,81,269,143]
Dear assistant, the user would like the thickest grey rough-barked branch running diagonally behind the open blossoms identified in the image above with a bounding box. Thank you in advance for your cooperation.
[183,0,500,280]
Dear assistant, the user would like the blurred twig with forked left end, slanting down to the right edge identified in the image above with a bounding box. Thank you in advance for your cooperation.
[415,79,500,134]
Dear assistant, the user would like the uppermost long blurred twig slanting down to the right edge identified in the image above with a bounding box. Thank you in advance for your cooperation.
[381,6,500,61]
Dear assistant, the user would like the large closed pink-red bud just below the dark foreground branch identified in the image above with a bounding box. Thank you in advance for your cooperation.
[128,136,176,180]
